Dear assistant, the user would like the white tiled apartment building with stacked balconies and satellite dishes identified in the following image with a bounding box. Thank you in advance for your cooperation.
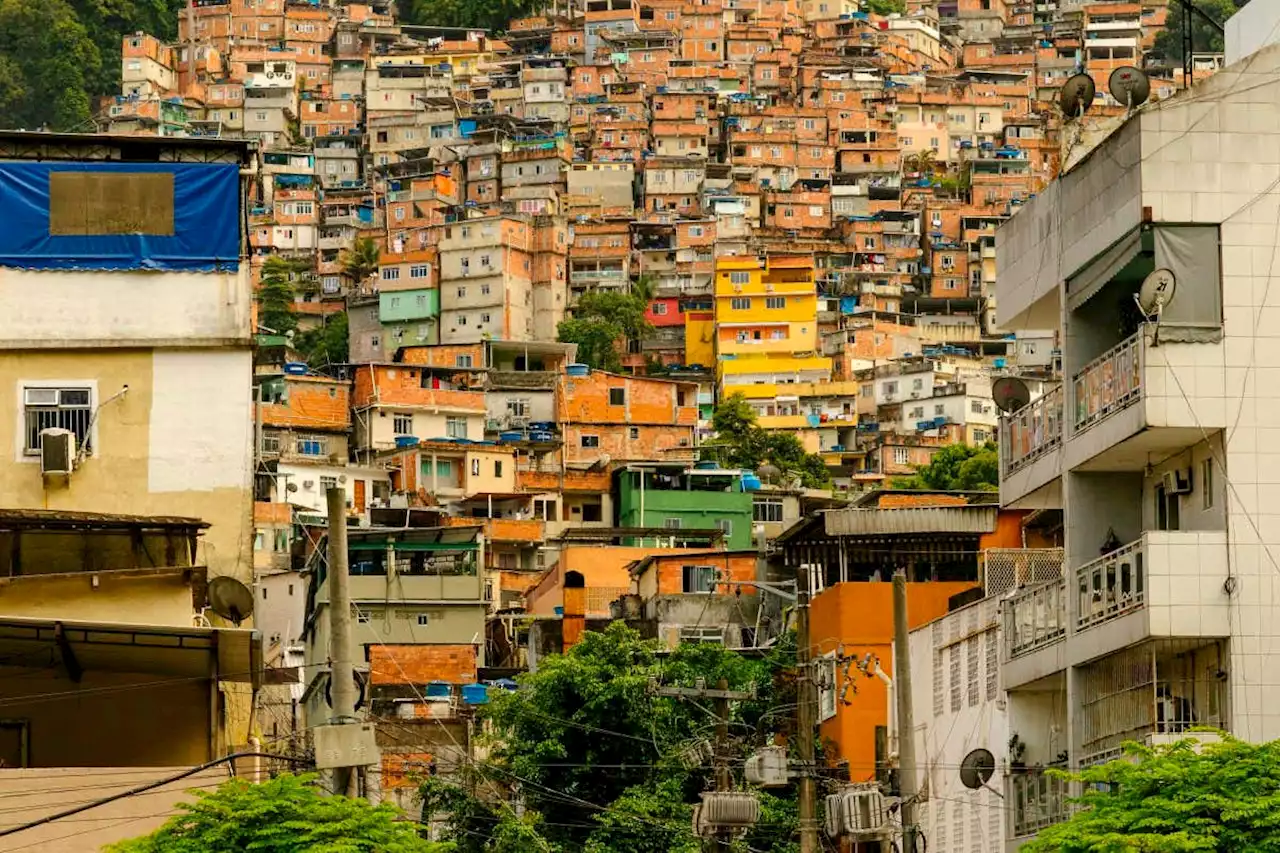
[996,46,1280,847]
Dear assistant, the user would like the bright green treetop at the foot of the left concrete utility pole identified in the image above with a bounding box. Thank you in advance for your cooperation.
[109,774,449,853]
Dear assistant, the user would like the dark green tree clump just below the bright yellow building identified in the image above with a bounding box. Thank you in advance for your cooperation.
[709,393,831,488]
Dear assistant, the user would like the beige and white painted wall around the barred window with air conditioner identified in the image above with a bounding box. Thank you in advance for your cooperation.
[0,348,253,584]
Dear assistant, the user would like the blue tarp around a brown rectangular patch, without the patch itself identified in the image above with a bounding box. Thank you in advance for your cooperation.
[0,161,241,272]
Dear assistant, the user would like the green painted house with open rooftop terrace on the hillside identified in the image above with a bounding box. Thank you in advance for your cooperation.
[617,462,753,551]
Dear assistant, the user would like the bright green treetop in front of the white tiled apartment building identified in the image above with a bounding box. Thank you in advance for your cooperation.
[1023,735,1280,853]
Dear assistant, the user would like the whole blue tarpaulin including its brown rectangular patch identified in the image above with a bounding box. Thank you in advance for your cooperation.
[0,161,241,272]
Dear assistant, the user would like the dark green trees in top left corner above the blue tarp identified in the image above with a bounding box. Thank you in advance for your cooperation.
[0,0,101,131]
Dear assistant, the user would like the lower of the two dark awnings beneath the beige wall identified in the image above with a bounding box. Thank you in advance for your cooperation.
[0,617,262,689]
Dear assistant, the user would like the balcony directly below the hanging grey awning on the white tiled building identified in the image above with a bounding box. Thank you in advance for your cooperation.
[1065,325,1228,471]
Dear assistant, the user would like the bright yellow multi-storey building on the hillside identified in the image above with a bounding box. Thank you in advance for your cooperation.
[714,256,832,398]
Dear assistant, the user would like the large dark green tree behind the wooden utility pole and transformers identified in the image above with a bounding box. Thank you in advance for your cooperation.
[422,622,796,853]
